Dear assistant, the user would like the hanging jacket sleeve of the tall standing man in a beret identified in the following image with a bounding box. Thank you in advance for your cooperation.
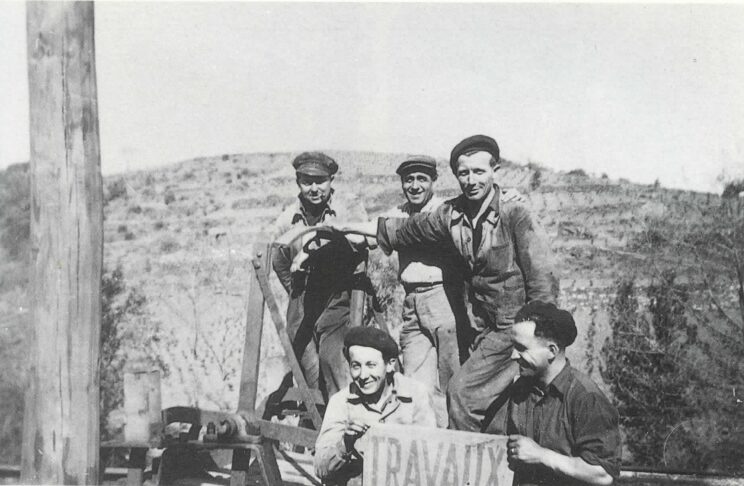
[511,204,558,302]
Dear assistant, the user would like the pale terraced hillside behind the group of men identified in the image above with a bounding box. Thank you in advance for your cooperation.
[0,152,732,409]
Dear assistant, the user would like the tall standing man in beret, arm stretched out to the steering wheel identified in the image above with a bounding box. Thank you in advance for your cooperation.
[338,135,558,431]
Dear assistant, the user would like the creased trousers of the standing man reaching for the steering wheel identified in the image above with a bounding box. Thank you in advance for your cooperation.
[447,328,519,432]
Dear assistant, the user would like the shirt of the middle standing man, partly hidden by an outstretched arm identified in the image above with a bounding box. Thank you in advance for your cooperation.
[383,196,459,288]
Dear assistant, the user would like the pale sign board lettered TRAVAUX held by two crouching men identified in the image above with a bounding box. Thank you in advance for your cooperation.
[363,424,513,486]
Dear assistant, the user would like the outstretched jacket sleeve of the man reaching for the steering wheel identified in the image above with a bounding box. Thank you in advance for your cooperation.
[377,204,451,255]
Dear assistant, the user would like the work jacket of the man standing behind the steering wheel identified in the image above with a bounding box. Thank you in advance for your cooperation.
[267,193,369,295]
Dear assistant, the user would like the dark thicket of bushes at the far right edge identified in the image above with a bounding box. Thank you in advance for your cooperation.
[603,206,744,474]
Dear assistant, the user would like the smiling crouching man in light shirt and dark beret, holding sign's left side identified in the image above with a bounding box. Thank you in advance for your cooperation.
[314,327,436,485]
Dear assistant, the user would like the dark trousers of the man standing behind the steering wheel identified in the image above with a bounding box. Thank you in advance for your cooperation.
[287,290,351,400]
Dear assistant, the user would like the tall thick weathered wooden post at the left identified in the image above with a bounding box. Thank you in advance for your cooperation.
[21,2,103,484]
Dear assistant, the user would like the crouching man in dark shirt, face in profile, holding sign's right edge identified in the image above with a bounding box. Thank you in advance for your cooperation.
[484,301,621,486]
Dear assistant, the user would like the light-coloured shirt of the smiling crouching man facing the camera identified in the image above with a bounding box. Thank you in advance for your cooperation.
[315,372,437,484]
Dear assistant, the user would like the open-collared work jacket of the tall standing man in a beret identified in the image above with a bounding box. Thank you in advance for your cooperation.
[377,186,558,331]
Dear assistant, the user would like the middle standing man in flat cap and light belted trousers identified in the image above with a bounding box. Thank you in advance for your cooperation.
[384,155,467,426]
